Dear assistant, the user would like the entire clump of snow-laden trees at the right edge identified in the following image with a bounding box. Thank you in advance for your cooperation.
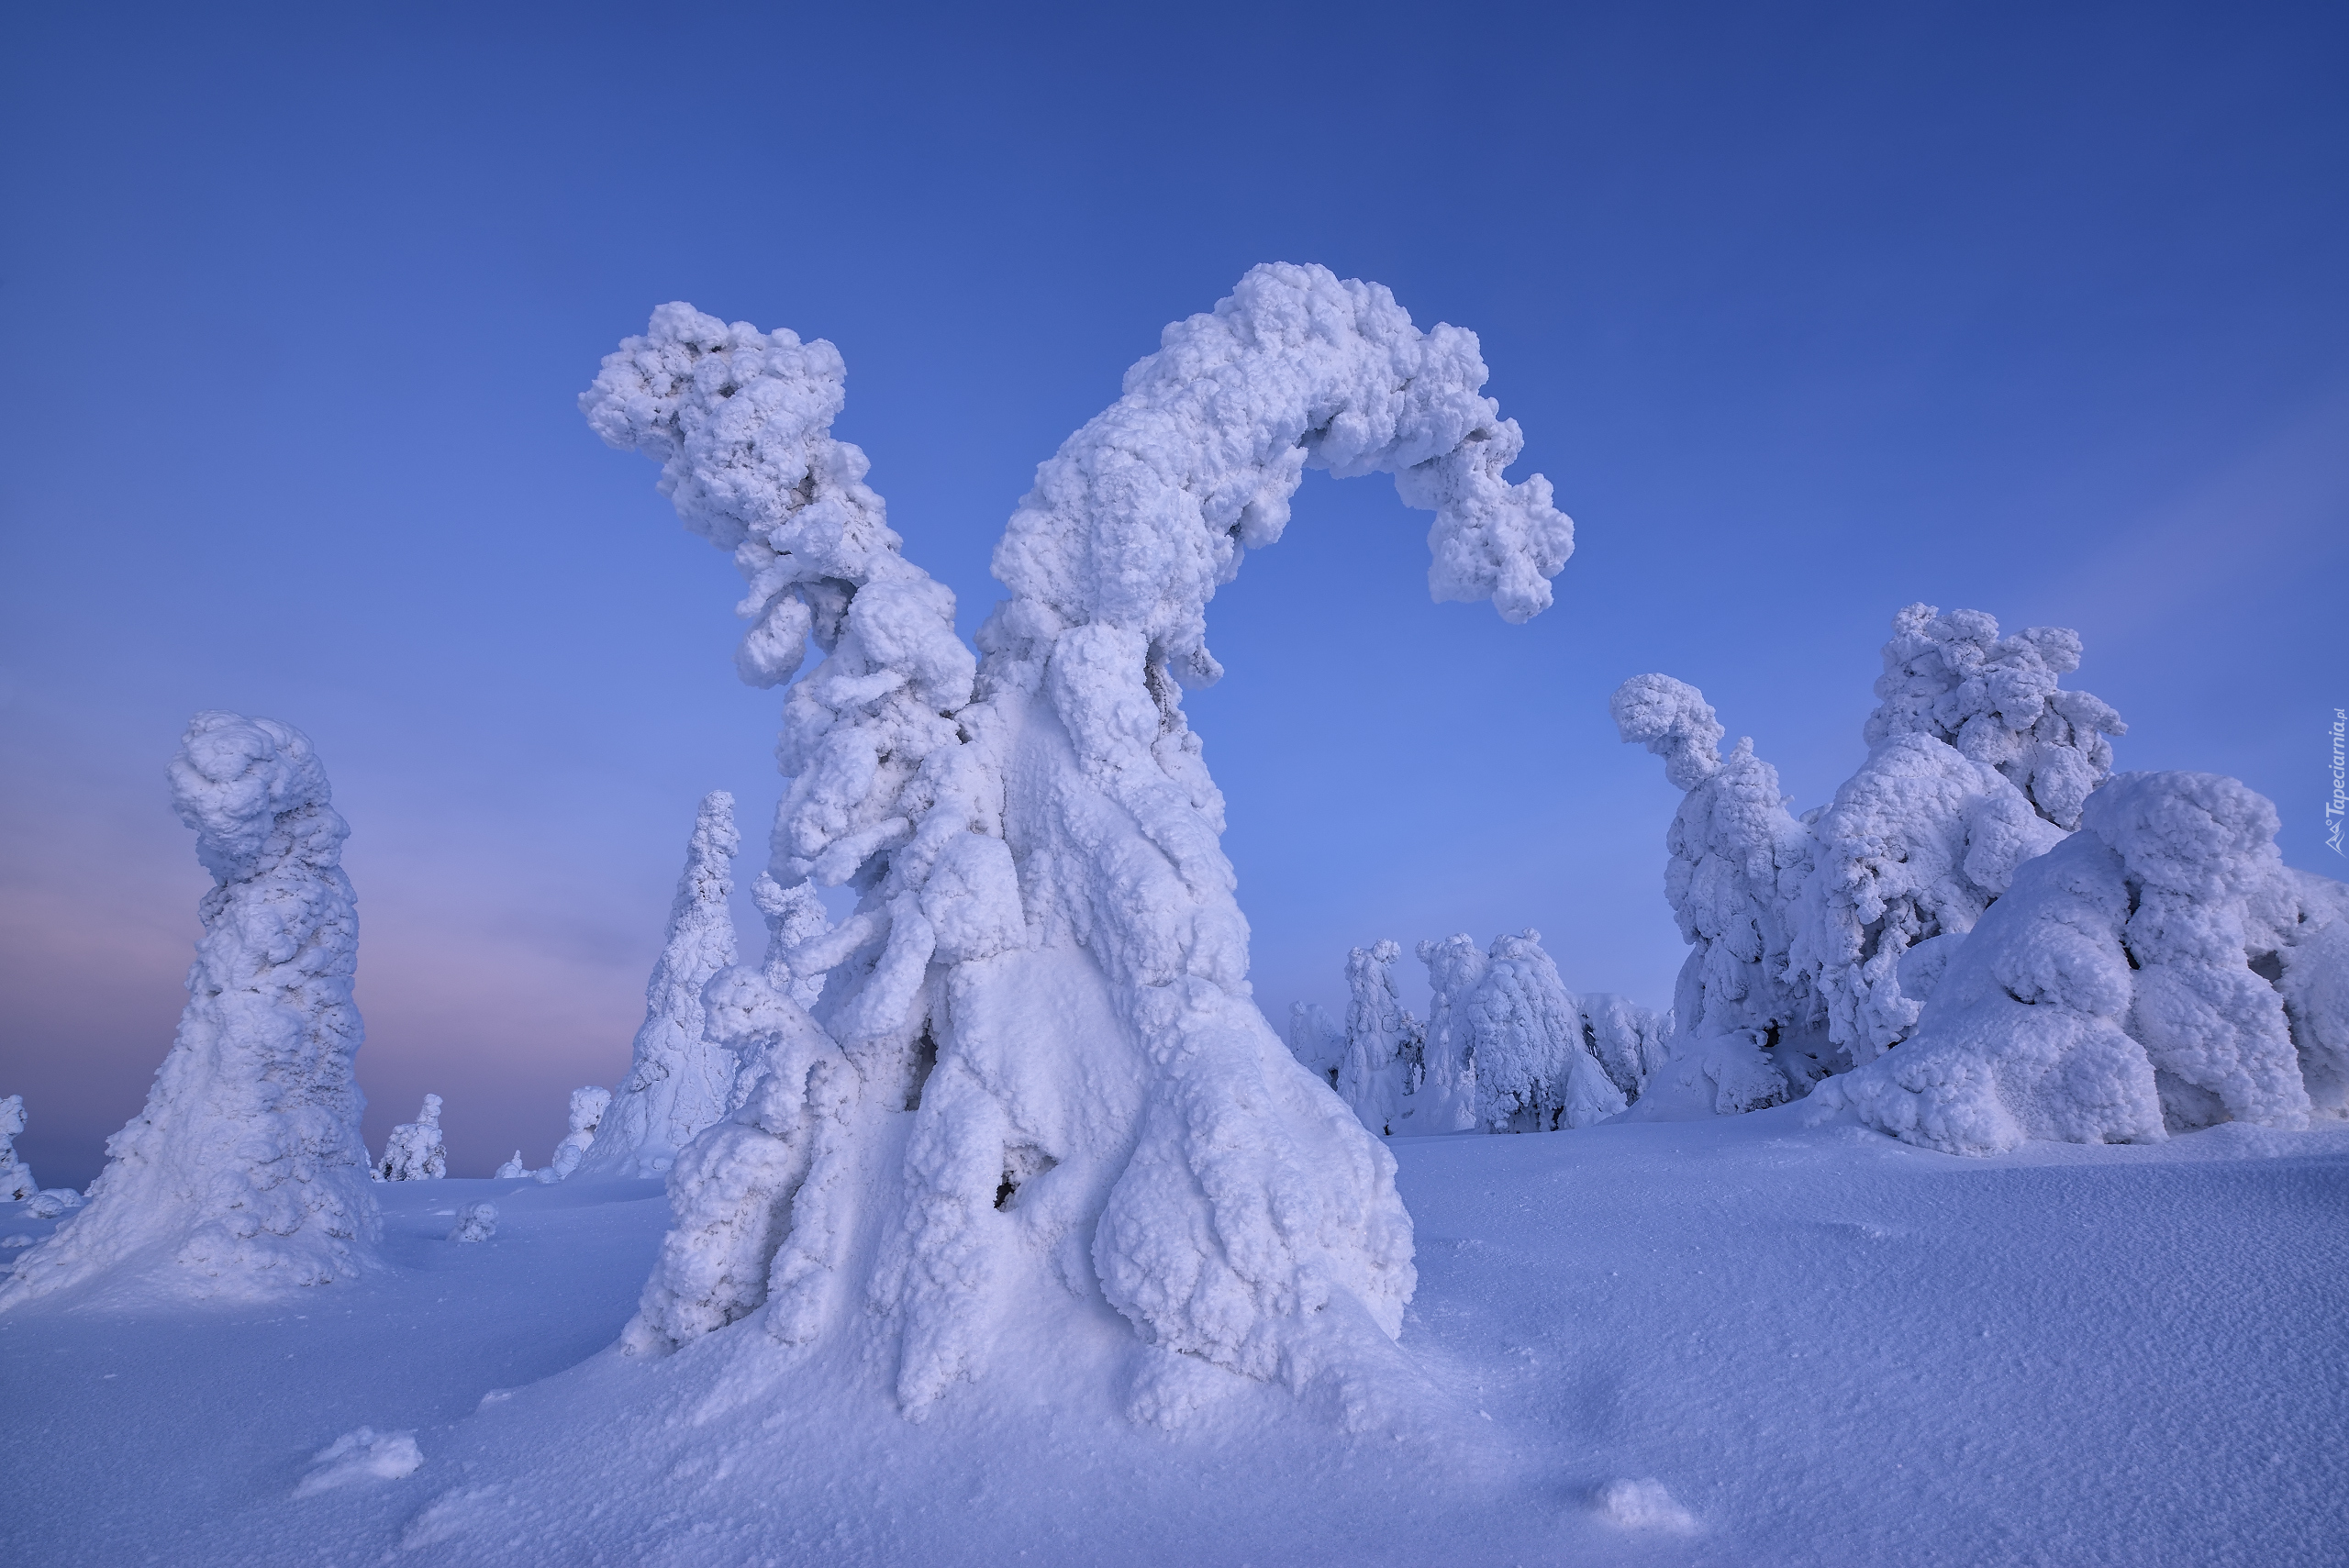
[1614,604,2349,1152]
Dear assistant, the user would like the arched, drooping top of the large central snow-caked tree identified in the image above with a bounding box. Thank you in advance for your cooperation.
[980,263,1574,688]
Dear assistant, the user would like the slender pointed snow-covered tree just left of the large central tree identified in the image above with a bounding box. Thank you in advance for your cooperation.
[575,789,742,1176]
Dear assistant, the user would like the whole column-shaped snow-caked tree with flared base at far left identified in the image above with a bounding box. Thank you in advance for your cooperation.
[0,714,376,1307]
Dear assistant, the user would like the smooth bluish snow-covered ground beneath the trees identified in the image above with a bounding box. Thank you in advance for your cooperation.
[0,1106,2349,1568]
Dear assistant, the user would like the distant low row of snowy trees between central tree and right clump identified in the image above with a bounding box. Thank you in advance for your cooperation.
[1289,929,1673,1136]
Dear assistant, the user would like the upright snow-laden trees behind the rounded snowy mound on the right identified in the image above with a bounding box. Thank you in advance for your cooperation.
[1611,604,2123,1113]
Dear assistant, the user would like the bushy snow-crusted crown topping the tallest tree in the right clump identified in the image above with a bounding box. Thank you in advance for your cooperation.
[1863,604,2128,828]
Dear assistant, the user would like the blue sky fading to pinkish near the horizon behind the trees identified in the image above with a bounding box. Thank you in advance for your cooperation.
[0,5,2349,1183]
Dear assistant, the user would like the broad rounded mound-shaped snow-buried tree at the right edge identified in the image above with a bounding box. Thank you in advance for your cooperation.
[1813,773,2349,1155]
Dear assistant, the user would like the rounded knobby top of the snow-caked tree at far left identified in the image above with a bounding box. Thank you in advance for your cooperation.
[172,714,350,885]
